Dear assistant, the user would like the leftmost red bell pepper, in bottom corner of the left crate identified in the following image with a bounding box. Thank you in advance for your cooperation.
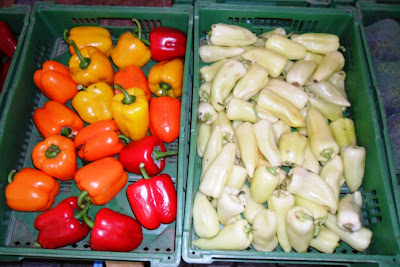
[34,197,90,249]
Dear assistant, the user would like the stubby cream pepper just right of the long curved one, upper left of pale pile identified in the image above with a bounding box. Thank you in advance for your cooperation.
[232,64,268,101]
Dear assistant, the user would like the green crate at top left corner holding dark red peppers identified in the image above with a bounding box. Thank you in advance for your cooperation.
[0,5,31,119]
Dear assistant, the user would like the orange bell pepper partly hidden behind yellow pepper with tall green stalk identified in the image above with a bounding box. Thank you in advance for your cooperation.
[114,65,151,101]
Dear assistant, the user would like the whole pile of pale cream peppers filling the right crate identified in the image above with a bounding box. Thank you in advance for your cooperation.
[191,23,372,253]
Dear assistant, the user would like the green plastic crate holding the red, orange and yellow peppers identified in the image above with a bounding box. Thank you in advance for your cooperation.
[0,3,193,266]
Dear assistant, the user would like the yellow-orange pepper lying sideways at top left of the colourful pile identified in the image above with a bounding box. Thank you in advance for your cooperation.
[65,26,114,57]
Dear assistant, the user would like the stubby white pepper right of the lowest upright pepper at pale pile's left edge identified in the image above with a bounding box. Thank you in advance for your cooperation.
[217,185,246,225]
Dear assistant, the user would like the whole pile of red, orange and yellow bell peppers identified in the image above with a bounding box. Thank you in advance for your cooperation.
[2,19,186,252]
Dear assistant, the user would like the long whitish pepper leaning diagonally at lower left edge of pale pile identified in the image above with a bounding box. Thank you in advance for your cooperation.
[199,143,236,198]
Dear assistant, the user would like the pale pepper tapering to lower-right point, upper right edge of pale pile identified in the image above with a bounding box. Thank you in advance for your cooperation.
[306,81,351,107]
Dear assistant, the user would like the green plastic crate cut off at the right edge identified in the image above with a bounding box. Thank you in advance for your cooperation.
[357,1,400,234]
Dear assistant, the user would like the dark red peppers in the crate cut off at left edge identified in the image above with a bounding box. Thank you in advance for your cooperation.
[0,21,18,93]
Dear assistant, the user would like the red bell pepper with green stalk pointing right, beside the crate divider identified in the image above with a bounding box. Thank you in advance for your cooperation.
[118,135,178,176]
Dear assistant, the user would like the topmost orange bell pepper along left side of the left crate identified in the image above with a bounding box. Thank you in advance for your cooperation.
[33,60,79,104]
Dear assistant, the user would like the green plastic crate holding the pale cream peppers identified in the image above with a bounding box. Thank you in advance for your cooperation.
[182,2,400,265]
